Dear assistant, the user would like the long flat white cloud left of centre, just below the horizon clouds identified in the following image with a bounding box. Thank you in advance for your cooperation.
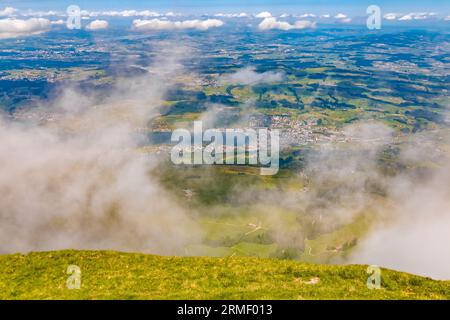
[133,19,223,30]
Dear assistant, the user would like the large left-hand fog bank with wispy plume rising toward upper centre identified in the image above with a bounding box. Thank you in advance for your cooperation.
[0,48,201,254]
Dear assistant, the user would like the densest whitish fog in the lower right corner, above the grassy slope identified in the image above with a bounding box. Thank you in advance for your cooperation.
[350,130,450,280]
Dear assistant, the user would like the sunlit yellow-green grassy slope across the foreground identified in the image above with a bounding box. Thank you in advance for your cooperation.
[0,251,450,299]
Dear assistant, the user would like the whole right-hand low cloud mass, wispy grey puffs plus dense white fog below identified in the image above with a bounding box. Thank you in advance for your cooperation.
[294,122,450,280]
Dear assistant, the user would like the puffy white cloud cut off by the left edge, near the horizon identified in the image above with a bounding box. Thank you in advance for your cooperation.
[0,18,51,39]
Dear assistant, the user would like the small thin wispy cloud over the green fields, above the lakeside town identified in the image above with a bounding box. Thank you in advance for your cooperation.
[220,67,285,85]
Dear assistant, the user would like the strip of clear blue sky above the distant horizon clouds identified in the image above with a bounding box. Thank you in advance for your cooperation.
[0,0,450,15]
